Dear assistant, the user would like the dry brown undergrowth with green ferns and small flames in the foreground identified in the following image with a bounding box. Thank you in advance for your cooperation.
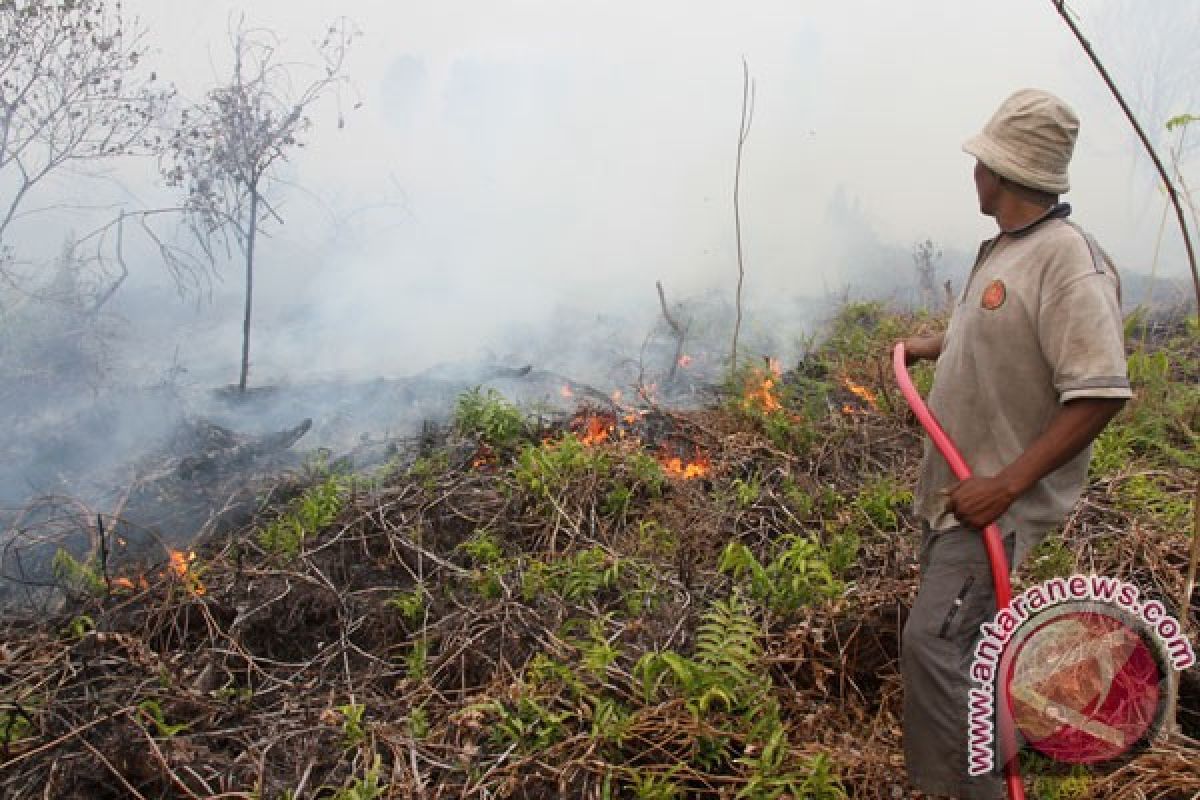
[0,307,1200,799]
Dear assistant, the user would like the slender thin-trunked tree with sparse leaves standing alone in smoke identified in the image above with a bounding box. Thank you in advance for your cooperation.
[164,19,355,391]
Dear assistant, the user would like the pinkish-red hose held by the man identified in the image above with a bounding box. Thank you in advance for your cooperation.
[892,342,1025,800]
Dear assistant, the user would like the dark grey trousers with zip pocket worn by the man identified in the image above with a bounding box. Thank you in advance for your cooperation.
[900,528,1015,800]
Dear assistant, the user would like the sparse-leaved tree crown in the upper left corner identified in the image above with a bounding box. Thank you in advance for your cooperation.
[0,0,170,263]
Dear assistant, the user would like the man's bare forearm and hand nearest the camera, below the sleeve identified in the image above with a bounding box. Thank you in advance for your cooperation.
[946,397,1126,528]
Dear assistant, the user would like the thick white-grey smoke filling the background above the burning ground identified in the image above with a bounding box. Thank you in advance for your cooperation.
[0,0,1200,587]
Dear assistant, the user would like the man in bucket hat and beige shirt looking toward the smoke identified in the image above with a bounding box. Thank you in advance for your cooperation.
[900,89,1130,798]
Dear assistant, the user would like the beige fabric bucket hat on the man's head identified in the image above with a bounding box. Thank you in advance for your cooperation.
[962,89,1079,194]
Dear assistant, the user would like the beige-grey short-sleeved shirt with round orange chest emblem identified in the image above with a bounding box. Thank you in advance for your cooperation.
[916,204,1132,569]
